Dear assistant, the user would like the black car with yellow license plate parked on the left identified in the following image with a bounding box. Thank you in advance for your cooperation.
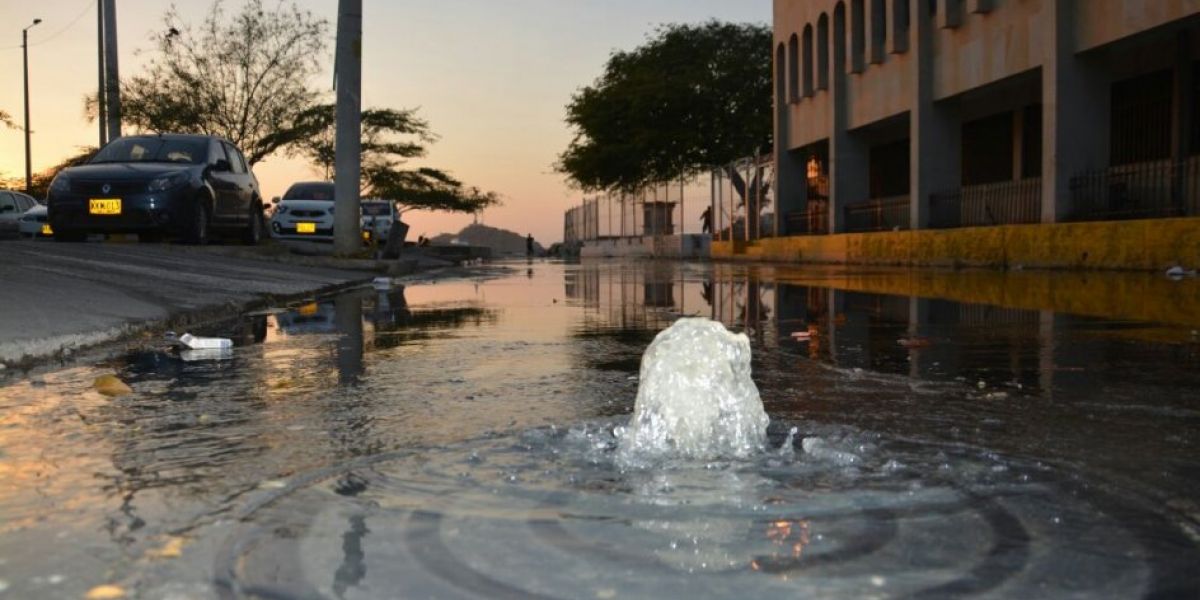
[47,134,263,244]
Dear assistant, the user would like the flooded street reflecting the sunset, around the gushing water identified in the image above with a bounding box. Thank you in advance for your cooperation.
[0,262,1200,599]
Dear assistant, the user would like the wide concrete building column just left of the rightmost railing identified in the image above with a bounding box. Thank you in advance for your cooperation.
[1042,0,1112,223]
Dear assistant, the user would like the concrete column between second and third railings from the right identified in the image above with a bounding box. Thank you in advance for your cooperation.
[908,1,962,229]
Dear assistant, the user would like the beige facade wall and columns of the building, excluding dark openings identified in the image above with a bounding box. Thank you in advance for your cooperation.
[774,0,1200,233]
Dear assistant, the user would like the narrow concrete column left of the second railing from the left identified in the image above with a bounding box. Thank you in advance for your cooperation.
[829,6,870,233]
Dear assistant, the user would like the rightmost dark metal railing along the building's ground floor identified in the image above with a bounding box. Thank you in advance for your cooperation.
[1068,157,1200,221]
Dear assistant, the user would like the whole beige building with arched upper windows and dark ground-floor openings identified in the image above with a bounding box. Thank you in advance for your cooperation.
[774,0,1200,235]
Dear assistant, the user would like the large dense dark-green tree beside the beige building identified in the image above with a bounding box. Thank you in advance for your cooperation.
[558,22,772,191]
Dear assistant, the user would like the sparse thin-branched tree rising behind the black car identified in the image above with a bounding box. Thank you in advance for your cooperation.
[112,0,329,164]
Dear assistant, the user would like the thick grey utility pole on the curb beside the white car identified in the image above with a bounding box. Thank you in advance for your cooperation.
[333,0,362,257]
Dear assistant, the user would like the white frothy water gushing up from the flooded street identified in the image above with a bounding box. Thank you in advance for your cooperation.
[618,318,769,467]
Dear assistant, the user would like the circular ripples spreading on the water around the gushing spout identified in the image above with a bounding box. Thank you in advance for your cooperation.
[217,421,1195,598]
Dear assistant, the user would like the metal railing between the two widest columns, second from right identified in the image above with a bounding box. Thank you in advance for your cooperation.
[929,178,1042,229]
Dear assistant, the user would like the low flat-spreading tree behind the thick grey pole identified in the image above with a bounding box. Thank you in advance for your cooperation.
[286,104,500,212]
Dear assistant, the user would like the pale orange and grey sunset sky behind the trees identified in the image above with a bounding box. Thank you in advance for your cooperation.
[0,0,770,242]
